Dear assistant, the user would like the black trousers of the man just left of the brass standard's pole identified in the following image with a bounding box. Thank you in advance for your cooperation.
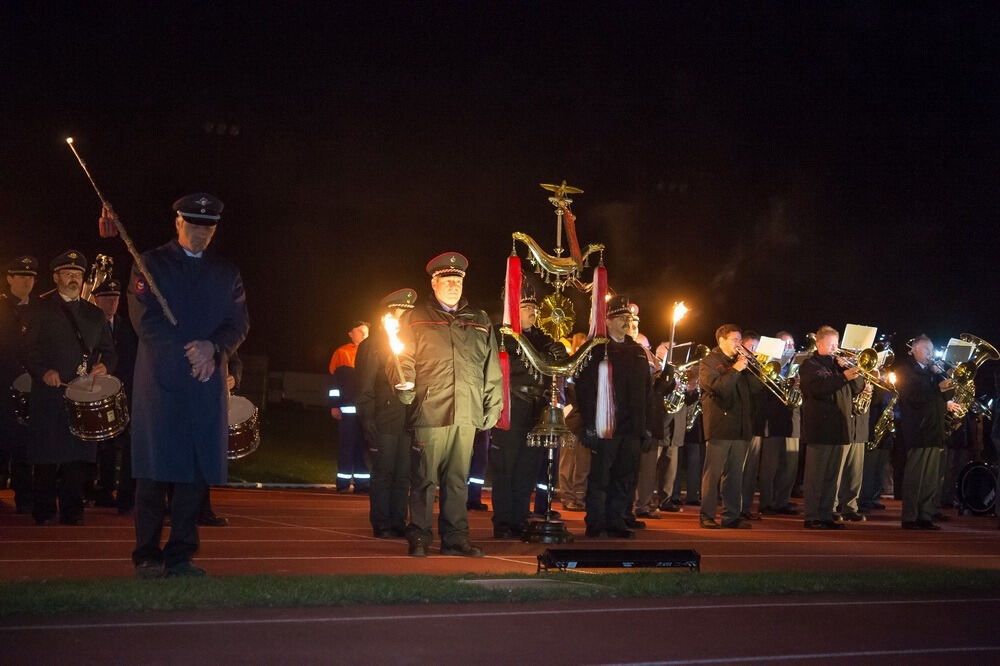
[489,426,544,528]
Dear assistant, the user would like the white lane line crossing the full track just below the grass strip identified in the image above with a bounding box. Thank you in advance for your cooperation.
[0,597,1000,632]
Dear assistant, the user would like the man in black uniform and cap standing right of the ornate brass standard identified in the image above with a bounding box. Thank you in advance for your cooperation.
[576,296,651,539]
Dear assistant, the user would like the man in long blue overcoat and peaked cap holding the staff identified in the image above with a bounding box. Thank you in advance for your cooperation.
[125,193,250,578]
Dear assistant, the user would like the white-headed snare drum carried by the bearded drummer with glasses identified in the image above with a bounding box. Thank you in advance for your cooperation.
[64,375,129,442]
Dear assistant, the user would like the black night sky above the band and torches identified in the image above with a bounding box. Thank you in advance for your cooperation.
[0,2,1000,371]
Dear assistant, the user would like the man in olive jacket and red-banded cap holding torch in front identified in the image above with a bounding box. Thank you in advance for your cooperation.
[389,252,503,557]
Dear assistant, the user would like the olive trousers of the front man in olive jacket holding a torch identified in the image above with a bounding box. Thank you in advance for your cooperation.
[407,425,476,546]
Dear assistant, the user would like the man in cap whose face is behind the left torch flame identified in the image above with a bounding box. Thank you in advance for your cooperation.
[354,289,417,539]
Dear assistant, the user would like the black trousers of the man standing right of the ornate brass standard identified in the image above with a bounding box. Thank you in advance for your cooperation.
[584,435,639,530]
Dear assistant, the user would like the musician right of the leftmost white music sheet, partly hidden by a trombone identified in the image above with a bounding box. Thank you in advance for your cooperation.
[759,331,802,516]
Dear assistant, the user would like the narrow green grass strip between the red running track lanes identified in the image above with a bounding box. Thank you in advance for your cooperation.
[0,569,1000,617]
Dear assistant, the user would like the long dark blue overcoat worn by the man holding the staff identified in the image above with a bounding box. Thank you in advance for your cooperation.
[128,239,250,484]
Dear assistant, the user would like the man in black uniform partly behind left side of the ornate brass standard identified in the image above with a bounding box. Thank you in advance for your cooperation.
[489,288,552,539]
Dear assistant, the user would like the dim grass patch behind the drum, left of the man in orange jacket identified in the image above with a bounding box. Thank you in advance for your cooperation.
[229,405,338,483]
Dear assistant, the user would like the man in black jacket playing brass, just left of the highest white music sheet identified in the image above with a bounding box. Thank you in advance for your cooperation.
[799,326,864,529]
